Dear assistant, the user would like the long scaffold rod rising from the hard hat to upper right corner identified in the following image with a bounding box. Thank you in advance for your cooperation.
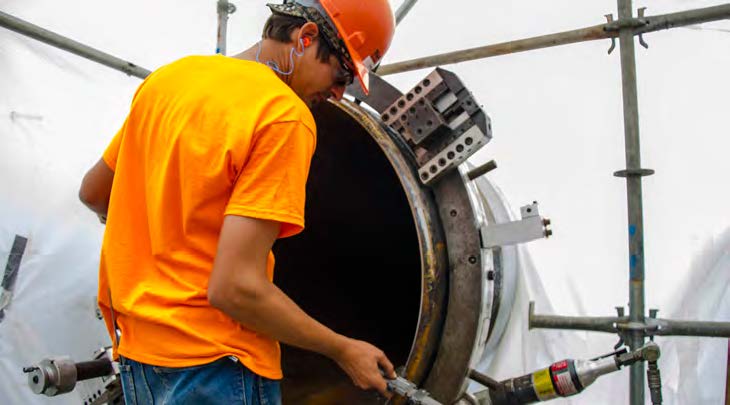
[378,4,730,76]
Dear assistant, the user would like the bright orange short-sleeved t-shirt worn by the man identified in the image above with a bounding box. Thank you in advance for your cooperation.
[98,56,316,379]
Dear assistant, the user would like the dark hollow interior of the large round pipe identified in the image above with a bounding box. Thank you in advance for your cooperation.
[274,104,421,404]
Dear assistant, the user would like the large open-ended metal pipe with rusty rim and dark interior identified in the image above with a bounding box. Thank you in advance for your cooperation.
[274,101,517,405]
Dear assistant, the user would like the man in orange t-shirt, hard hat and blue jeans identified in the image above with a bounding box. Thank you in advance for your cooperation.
[79,0,395,405]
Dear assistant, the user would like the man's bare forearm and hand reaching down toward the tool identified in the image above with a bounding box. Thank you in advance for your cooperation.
[208,215,395,396]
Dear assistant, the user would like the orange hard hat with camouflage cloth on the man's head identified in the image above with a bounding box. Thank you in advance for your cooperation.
[268,0,395,94]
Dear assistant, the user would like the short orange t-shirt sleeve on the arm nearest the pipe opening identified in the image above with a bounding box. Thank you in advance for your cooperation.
[225,121,315,238]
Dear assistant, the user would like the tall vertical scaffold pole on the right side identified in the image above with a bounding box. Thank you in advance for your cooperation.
[617,0,645,405]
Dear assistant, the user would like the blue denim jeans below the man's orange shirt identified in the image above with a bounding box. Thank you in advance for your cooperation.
[119,356,281,405]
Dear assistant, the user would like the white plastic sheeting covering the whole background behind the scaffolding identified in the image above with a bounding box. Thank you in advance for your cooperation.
[0,0,730,404]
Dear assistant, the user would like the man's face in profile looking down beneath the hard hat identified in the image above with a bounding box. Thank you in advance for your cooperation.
[292,39,352,107]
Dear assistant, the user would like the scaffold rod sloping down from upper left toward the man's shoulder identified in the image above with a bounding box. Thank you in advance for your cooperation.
[0,11,150,79]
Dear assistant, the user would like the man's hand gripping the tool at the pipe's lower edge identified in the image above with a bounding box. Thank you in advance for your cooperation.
[333,338,396,398]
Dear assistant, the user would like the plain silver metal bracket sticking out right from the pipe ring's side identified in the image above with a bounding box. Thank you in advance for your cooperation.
[479,201,553,248]
